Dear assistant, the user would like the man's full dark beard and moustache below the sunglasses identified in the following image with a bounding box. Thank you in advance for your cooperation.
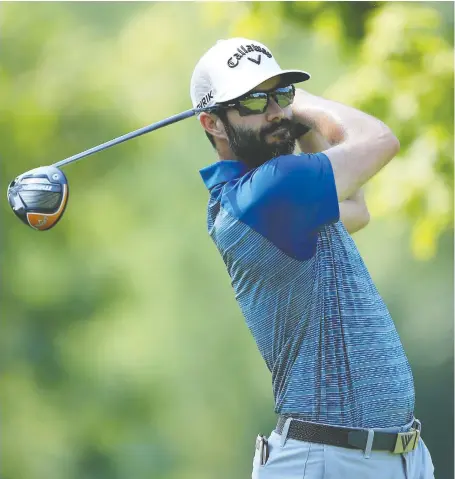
[223,119,296,168]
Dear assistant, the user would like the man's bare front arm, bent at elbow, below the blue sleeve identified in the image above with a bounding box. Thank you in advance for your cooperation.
[293,89,400,203]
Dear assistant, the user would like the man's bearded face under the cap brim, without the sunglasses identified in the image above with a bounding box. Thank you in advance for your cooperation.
[222,78,296,168]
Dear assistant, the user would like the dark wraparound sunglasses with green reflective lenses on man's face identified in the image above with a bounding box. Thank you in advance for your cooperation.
[217,85,295,116]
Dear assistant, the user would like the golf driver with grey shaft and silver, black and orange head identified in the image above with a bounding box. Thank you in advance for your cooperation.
[7,107,213,231]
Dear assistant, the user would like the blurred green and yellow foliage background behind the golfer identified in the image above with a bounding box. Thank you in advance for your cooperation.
[0,2,454,479]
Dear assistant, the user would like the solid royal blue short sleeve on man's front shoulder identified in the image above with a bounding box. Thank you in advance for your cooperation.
[225,153,340,256]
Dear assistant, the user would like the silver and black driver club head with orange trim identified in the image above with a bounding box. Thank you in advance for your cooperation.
[7,166,69,231]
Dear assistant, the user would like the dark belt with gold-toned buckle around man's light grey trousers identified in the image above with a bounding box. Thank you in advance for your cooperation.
[276,416,421,454]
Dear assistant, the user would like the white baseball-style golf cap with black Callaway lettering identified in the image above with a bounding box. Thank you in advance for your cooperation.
[190,38,310,108]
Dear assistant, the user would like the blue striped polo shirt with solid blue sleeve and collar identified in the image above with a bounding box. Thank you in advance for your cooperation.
[200,153,414,428]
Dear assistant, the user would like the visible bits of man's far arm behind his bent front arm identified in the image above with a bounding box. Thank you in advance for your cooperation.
[297,122,370,234]
